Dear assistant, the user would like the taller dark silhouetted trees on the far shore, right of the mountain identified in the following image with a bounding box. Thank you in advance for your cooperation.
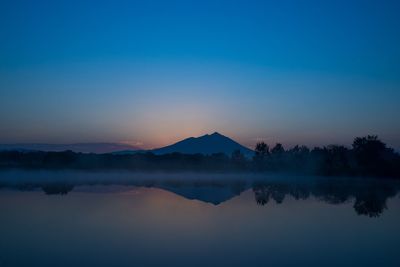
[253,135,400,177]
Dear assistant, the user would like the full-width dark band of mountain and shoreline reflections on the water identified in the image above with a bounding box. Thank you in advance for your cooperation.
[0,172,400,217]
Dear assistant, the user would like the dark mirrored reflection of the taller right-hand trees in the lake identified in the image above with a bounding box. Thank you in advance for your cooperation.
[253,180,398,217]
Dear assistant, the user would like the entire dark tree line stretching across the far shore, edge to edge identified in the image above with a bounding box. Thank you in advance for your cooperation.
[0,136,400,178]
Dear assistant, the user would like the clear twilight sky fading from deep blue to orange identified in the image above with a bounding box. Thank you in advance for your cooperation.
[0,0,400,149]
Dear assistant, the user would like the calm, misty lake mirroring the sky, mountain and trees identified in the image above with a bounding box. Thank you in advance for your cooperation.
[0,171,400,266]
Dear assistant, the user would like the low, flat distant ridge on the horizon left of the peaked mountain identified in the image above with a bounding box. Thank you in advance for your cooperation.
[0,143,138,153]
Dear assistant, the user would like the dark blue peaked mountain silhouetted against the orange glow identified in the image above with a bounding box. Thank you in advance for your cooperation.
[151,132,254,157]
